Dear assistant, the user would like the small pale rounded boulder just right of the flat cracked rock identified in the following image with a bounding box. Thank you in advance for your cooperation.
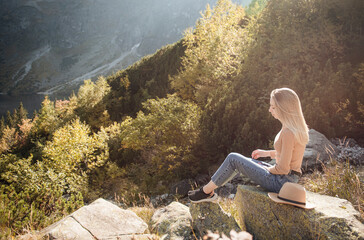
[151,202,194,240]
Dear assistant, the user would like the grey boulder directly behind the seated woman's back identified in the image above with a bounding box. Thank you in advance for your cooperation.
[302,129,340,172]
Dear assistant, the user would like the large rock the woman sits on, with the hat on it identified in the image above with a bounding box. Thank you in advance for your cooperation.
[235,185,364,240]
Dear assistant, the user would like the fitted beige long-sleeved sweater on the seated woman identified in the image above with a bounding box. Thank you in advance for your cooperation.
[268,128,306,175]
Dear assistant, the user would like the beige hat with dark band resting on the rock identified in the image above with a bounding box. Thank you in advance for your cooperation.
[268,182,315,209]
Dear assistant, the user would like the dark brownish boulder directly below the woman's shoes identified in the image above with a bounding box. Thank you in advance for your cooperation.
[190,202,241,236]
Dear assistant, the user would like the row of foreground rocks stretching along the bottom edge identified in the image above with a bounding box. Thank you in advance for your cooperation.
[32,185,364,240]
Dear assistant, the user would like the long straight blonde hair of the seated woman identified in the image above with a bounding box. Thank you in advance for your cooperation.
[270,88,308,145]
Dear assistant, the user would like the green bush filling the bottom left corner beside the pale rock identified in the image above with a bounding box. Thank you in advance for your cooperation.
[0,154,83,238]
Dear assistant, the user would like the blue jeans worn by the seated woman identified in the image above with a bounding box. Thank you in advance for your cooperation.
[211,153,299,193]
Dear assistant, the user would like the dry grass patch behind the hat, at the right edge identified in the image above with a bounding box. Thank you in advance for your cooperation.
[301,159,364,220]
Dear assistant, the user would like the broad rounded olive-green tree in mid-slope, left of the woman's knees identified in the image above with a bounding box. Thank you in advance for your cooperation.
[121,94,201,188]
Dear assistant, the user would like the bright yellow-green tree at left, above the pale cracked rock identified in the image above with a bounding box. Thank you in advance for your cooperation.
[42,119,108,193]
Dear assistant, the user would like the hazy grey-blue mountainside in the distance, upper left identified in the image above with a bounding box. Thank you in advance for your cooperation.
[0,0,222,96]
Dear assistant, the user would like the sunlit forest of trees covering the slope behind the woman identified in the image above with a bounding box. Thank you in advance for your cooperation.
[0,0,364,238]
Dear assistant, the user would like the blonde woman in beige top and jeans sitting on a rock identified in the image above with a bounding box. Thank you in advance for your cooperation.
[188,88,308,203]
